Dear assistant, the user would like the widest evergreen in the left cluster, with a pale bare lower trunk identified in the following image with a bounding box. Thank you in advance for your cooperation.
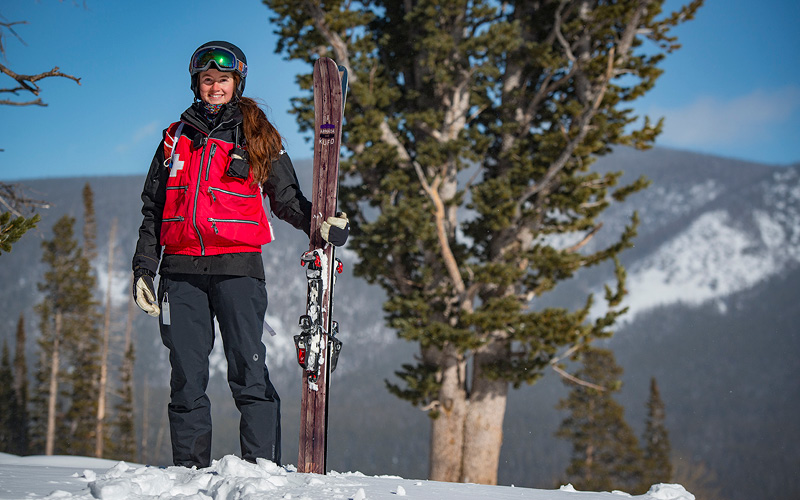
[35,216,98,455]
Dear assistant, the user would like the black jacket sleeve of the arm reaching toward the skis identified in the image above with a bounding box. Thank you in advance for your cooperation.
[263,153,311,234]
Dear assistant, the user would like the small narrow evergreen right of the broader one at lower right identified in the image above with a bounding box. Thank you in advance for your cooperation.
[642,378,672,491]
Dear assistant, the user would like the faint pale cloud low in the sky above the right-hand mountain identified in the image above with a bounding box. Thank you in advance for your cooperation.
[648,85,800,148]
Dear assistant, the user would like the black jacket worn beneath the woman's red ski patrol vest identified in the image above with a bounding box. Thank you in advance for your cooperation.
[132,103,311,279]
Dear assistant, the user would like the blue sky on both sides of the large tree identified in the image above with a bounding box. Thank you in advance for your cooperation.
[0,0,800,181]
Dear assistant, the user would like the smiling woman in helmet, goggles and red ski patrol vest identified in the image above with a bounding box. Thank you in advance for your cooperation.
[133,41,349,468]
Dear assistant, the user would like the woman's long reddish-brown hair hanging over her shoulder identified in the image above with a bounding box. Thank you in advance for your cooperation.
[236,79,283,184]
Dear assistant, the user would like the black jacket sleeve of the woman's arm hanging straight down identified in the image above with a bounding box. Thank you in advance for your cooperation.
[132,134,169,276]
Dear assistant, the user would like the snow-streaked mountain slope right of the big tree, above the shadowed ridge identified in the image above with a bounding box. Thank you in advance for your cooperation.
[600,146,800,321]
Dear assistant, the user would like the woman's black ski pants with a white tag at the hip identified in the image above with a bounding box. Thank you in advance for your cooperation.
[158,274,281,468]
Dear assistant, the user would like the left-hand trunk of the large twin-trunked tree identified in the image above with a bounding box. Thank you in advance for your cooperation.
[423,347,467,482]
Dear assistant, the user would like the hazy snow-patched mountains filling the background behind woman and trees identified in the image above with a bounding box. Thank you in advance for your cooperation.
[0,148,800,500]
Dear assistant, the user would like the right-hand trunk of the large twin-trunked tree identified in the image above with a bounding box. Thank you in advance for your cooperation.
[460,342,508,484]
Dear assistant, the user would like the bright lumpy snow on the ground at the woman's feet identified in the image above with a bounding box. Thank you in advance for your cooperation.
[0,453,695,500]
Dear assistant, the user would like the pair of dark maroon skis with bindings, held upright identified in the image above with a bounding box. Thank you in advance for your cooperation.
[294,57,347,474]
